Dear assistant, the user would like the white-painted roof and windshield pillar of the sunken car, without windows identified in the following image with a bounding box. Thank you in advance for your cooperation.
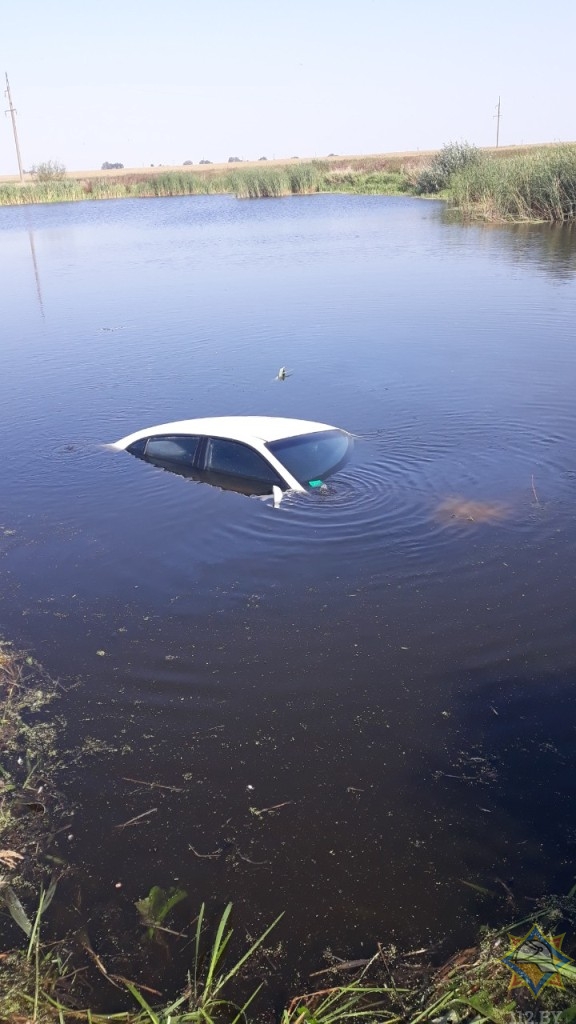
[109,416,352,492]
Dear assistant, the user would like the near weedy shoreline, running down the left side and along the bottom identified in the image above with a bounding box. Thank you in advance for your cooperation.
[0,643,576,1024]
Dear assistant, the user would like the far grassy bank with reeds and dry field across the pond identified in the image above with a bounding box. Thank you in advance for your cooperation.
[0,142,576,223]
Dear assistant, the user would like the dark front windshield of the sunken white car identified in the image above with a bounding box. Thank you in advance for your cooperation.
[266,430,353,486]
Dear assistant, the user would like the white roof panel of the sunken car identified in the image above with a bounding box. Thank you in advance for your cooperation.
[116,416,340,447]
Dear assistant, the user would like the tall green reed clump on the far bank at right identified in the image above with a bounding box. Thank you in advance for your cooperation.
[449,145,576,223]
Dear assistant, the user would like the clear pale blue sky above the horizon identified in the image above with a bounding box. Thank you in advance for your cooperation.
[0,0,576,174]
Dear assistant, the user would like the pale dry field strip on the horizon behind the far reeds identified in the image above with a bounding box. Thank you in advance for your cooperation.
[0,142,574,183]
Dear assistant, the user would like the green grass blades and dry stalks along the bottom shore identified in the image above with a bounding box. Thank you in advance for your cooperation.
[0,892,576,1024]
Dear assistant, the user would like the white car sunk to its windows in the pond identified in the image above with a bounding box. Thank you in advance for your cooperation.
[110,416,354,498]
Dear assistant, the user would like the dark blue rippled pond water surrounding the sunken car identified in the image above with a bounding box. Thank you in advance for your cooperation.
[0,196,576,983]
